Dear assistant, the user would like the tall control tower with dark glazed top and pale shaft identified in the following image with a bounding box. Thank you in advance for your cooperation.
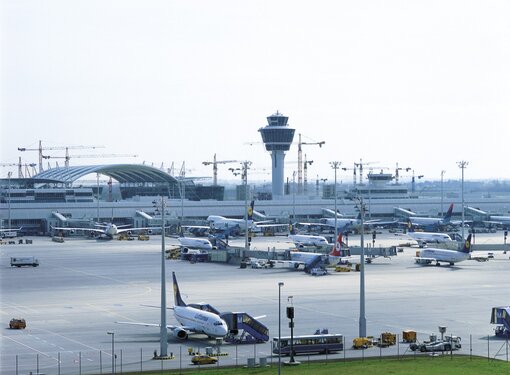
[259,111,295,199]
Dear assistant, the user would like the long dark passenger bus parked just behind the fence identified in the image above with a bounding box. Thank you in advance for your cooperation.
[273,333,344,355]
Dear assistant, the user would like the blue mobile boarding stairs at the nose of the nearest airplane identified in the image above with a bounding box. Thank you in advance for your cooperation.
[220,312,269,344]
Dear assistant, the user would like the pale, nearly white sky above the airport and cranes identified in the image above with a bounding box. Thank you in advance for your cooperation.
[0,0,510,184]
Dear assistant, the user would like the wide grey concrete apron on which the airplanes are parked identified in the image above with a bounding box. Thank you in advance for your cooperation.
[0,235,510,374]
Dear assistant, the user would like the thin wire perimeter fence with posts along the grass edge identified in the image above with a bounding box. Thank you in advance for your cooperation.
[2,335,510,375]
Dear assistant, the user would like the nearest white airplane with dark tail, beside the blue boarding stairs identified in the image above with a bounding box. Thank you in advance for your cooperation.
[115,272,228,340]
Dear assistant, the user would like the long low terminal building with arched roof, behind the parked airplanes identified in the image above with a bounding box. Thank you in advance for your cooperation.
[0,164,510,235]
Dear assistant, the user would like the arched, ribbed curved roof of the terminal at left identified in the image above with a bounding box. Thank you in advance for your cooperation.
[33,164,177,183]
